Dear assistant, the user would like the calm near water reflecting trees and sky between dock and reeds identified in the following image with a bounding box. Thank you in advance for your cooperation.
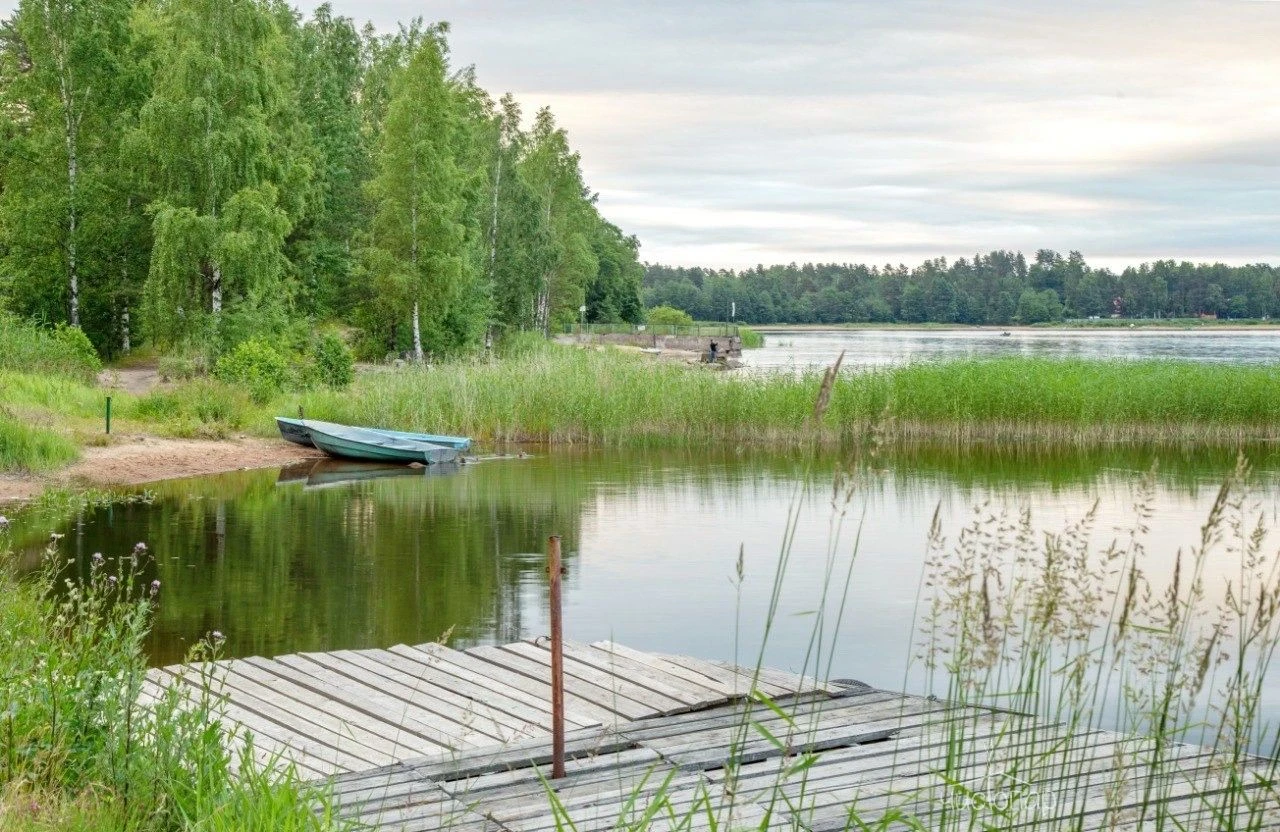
[17,449,1280,712]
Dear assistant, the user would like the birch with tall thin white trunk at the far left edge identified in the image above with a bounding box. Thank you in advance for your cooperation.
[0,0,137,342]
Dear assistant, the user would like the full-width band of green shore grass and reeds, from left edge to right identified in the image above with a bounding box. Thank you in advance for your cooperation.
[0,347,1280,471]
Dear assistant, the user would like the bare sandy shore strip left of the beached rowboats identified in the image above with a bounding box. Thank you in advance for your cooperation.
[0,436,324,503]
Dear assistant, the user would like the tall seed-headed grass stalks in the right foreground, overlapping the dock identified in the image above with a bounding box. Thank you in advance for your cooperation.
[519,448,1280,832]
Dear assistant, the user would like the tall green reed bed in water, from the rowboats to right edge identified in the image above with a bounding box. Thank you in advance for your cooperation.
[293,348,1280,445]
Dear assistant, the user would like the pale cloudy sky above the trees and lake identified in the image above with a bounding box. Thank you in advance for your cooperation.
[12,0,1280,268]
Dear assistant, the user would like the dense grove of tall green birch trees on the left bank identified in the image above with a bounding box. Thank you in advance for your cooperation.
[0,0,643,356]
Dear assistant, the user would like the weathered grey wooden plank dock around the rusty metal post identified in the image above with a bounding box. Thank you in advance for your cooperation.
[145,641,1280,832]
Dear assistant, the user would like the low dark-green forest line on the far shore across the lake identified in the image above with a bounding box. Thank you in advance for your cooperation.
[644,250,1280,324]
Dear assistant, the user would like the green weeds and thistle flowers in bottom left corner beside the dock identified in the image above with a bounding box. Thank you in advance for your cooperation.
[0,520,337,832]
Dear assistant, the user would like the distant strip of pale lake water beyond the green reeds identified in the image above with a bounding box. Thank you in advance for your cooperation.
[742,329,1280,369]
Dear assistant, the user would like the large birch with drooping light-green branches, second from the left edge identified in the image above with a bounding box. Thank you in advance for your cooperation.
[140,0,311,340]
